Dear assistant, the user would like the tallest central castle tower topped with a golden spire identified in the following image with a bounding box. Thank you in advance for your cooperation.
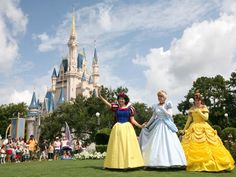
[66,16,77,101]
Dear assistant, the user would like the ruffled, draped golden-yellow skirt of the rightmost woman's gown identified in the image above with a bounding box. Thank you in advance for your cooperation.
[182,123,234,172]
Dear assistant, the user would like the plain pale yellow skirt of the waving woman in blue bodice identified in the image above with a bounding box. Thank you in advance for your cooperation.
[104,122,144,169]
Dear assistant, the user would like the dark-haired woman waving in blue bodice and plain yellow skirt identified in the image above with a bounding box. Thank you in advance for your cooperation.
[99,91,144,169]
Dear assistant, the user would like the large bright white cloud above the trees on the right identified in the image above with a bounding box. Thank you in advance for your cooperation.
[133,14,236,111]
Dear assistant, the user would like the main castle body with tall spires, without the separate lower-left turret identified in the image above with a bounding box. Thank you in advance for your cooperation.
[44,16,99,112]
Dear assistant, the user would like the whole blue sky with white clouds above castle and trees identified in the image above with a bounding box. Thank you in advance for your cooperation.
[0,0,236,111]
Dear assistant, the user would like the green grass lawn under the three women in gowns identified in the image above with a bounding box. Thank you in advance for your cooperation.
[0,160,236,177]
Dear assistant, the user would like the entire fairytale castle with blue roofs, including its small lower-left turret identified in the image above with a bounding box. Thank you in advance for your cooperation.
[26,16,99,138]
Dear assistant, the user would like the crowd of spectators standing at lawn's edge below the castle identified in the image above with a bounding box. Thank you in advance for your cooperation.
[0,135,83,164]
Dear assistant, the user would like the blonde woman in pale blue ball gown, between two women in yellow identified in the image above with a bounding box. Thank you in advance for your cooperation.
[139,90,186,168]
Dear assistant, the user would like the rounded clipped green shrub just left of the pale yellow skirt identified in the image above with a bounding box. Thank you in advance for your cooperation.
[95,128,111,145]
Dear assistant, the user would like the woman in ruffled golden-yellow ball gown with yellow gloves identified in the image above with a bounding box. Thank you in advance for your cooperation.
[182,92,234,172]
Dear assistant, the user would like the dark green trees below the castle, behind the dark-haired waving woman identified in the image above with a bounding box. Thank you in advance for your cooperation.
[41,86,151,142]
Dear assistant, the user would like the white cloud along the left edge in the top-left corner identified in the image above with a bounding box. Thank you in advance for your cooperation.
[0,0,27,73]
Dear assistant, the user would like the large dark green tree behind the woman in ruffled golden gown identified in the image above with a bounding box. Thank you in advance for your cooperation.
[178,75,228,127]
